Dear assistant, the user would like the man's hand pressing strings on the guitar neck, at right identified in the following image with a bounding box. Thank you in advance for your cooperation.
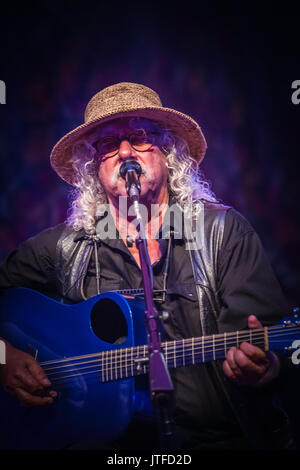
[223,315,280,387]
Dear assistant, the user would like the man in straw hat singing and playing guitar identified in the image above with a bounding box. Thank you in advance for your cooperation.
[1,83,288,449]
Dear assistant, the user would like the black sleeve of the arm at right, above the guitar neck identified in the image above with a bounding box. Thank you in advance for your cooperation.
[218,209,288,331]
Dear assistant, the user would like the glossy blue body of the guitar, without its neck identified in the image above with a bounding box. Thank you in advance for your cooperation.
[0,288,146,449]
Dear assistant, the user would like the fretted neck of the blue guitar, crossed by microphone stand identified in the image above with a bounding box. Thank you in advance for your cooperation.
[100,327,270,382]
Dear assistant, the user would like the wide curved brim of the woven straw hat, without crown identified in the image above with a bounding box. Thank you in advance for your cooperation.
[50,107,207,185]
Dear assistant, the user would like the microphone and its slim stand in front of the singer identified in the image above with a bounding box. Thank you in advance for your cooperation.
[125,169,179,450]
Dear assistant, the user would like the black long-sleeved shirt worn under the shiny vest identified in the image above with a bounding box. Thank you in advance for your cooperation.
[0,209,286,441]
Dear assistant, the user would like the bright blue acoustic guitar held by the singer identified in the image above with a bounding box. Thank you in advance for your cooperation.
[0,288,300,449]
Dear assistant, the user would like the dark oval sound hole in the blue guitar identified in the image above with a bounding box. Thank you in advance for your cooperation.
[91,299,128,344]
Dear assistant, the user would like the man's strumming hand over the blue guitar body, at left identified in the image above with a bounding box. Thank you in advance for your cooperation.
[0,343,57,406]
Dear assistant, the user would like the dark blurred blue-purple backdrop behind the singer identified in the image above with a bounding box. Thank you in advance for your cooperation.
[0,0,300,444]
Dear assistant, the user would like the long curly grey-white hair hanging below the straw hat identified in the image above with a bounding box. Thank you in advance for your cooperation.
[67,118,217,235]
